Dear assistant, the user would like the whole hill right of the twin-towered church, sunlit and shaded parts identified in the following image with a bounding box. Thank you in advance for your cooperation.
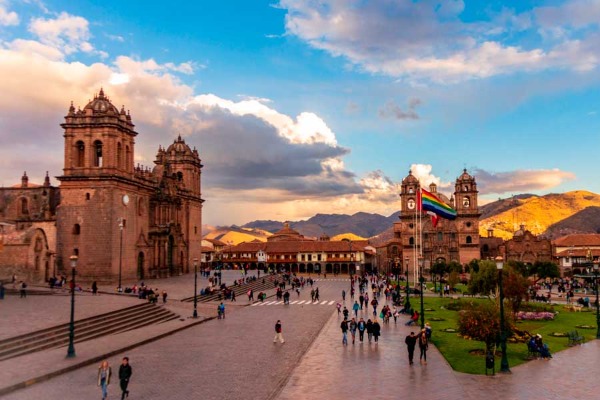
[479,190,600,239]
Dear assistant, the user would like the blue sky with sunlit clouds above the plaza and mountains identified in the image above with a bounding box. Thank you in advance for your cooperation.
[0,0,600,225]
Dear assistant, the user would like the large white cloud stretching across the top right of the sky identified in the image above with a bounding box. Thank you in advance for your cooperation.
[280,0,600,84]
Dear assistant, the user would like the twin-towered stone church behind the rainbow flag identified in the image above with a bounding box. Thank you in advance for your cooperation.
[394,169,481,276]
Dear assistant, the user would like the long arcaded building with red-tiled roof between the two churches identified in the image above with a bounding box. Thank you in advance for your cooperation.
[217,223,375,274]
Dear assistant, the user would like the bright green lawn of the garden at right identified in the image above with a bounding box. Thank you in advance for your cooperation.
[418,296,596,374]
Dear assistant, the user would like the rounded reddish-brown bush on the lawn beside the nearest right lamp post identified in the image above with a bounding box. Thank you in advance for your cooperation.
[458,301,512,353]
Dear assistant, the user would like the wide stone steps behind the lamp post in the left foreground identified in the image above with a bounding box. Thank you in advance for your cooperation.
[0,303,179,361]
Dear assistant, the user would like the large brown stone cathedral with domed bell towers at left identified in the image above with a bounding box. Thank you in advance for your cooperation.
[0,89,204,283]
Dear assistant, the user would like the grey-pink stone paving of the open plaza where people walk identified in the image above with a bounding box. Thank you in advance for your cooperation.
[0,272,600,400]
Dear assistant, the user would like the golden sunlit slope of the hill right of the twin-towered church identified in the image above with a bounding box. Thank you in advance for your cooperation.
[479,190,600,239]
